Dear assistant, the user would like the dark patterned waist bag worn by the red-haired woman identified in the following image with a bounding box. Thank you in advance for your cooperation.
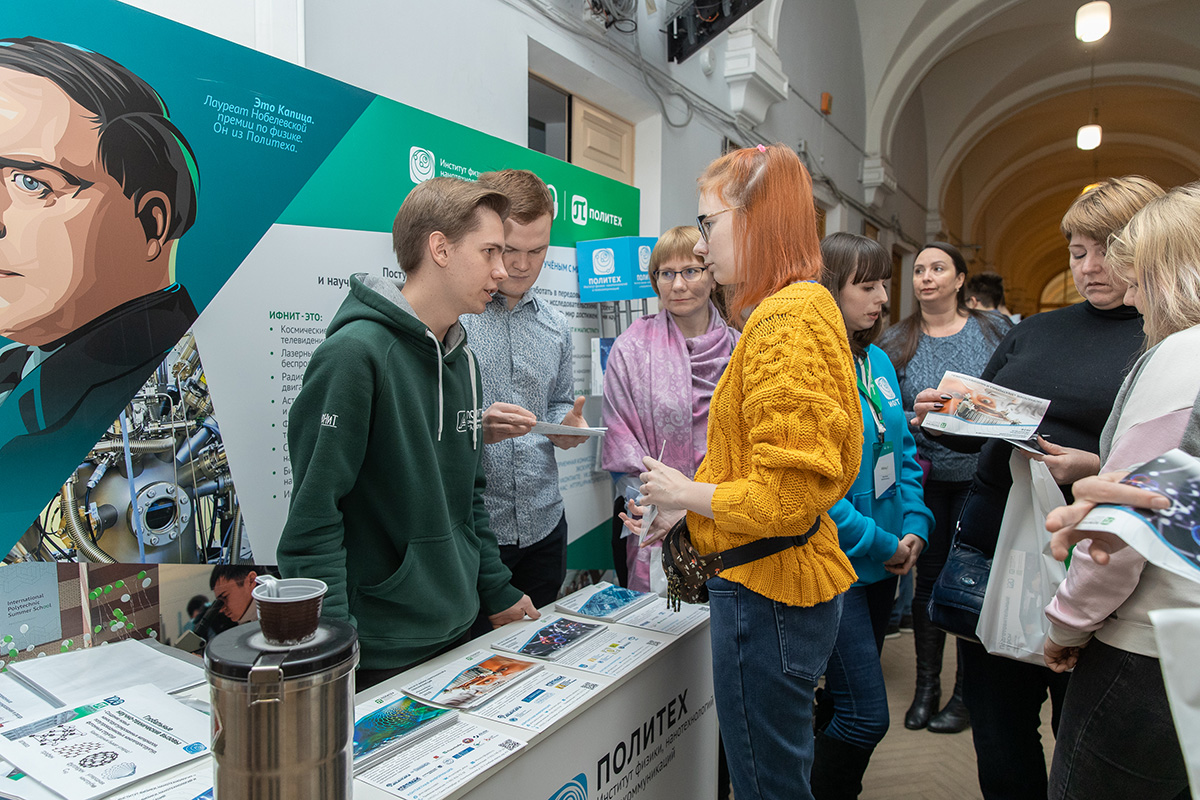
[662,515,821,610]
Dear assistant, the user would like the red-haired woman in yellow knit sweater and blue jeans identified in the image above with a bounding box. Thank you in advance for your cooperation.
[642,145,863,800]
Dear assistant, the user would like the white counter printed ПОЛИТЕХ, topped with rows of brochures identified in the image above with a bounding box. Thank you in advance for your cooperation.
[354,584,716,800]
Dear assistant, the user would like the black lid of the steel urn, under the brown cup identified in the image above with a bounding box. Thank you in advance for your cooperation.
[204,619,359,680]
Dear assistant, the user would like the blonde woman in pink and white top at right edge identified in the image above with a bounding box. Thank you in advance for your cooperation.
[1045,184,1200,800]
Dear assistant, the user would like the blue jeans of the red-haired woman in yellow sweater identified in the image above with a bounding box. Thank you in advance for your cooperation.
[708,578,842,800]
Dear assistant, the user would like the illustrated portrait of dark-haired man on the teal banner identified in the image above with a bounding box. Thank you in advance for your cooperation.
[0,37,199,460]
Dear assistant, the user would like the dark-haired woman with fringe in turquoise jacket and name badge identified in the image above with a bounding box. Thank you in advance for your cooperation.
[811,227,934,800]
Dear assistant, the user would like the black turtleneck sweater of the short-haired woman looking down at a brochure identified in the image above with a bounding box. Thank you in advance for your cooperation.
[946,301,1144,555]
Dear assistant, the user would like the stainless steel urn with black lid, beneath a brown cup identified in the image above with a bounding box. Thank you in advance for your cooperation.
[204,619,359,800]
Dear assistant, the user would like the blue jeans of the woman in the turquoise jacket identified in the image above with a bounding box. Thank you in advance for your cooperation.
[826,578,895,750]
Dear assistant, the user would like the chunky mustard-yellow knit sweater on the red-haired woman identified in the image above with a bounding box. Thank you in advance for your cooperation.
[688,283,863,606]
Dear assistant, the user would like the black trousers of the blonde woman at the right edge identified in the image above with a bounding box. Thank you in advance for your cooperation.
[1050,639,1189,800]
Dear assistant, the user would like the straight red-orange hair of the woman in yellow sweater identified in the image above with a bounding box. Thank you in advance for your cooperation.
[700,144,821,327]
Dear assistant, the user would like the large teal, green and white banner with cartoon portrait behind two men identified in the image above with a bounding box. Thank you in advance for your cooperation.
[0,0,638,560]
